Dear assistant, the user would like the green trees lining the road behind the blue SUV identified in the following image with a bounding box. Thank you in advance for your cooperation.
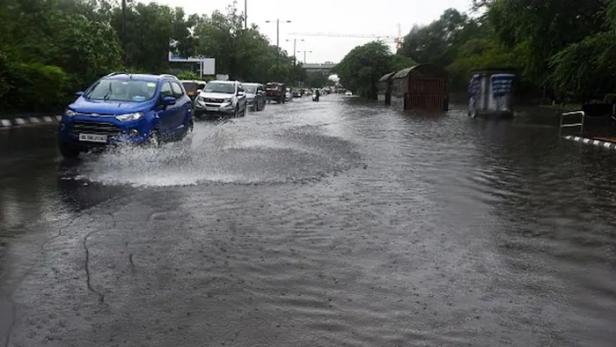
[0,0,322,112]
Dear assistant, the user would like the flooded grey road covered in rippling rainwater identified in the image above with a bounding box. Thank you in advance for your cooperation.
[0,95,616,347]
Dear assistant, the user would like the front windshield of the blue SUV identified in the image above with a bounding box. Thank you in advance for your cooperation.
[84,79,157,102]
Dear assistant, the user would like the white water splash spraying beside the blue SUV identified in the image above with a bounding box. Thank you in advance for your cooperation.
[71,125,359,187]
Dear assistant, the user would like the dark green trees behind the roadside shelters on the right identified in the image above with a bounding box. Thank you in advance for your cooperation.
[336,0,616,102]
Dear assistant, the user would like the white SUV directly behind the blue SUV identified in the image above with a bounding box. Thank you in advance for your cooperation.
[194,81,246,118]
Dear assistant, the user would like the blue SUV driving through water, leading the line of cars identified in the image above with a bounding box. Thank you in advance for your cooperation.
[59,73,194,158]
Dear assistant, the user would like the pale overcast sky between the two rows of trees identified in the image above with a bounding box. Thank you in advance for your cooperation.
[143,0,471,63]
